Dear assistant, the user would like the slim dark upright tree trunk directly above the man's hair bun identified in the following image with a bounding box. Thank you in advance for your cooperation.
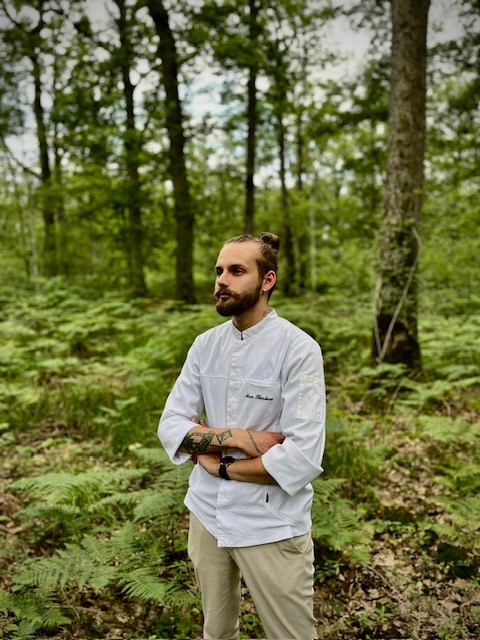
[245,0,258,234]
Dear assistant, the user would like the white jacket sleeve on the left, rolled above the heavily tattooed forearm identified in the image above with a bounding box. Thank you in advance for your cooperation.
[157,338,204,464]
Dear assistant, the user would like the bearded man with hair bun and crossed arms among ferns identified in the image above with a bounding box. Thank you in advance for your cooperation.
[158,233,325,640]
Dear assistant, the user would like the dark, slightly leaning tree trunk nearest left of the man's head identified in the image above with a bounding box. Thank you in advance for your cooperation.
[147,0,195,303]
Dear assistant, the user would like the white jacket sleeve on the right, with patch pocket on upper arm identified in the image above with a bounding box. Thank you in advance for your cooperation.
[262,335,326,495]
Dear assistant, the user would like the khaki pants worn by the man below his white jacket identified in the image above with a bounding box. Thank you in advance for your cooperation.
[188,514,317,640]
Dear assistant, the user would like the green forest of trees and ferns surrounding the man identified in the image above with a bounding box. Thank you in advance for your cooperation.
[0,0,480,640]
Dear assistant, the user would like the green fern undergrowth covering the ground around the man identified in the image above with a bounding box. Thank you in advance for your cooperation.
[0,282,480,640]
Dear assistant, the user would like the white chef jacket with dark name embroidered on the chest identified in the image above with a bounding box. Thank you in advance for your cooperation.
[158,310,325,547]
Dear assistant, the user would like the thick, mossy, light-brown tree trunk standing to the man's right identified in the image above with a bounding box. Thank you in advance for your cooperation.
[372,0,430,370]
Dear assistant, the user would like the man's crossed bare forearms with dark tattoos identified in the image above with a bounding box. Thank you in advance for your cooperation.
[178,420,285,484]
